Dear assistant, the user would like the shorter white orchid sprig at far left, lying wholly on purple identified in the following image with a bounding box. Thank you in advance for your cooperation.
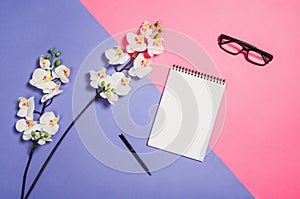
[15,48,70,199]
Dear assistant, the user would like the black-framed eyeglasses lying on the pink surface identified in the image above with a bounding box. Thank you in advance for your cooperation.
[218,34,273,66]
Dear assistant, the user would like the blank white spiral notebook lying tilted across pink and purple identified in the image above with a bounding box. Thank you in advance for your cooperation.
[147,65,226,161]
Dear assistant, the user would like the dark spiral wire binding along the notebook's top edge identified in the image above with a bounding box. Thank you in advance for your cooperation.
[172,64,225,85]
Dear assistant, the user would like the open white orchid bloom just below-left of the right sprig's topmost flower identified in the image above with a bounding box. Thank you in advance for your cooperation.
[126,32,147,53]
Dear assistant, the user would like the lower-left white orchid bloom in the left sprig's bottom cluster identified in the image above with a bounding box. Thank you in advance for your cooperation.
[15,119,40,140]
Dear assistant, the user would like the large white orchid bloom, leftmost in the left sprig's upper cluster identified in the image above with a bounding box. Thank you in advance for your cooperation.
[29,68,53,89]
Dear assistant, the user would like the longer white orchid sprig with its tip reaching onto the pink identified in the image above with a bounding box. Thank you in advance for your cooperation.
[25,21,164,199]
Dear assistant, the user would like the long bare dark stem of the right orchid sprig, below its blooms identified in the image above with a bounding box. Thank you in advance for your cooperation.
[24,93,100,199]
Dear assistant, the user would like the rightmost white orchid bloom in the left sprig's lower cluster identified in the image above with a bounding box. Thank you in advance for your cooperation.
[40,112,59,135]
